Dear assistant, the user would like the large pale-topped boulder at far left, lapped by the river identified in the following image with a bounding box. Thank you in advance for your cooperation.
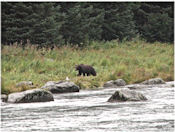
[7,89,54,103]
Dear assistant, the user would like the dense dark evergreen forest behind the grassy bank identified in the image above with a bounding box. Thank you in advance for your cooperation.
[1,2,174,46]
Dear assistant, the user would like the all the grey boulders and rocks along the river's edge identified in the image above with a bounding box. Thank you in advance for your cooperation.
[1,78,174,103]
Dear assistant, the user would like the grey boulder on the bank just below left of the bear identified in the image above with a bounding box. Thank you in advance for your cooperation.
[41,81,80,93]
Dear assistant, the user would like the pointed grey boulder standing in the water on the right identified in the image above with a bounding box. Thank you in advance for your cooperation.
[108,89,147,102]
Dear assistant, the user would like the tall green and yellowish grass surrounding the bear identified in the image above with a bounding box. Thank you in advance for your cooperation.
[1,40,174,94]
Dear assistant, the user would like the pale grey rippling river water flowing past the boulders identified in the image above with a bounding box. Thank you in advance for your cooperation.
[1,82,174,132]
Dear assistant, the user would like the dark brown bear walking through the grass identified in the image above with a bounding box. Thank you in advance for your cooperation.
[75,64,96,76]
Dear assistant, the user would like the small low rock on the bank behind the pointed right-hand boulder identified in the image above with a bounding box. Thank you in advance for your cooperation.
[103,79,126,87]
